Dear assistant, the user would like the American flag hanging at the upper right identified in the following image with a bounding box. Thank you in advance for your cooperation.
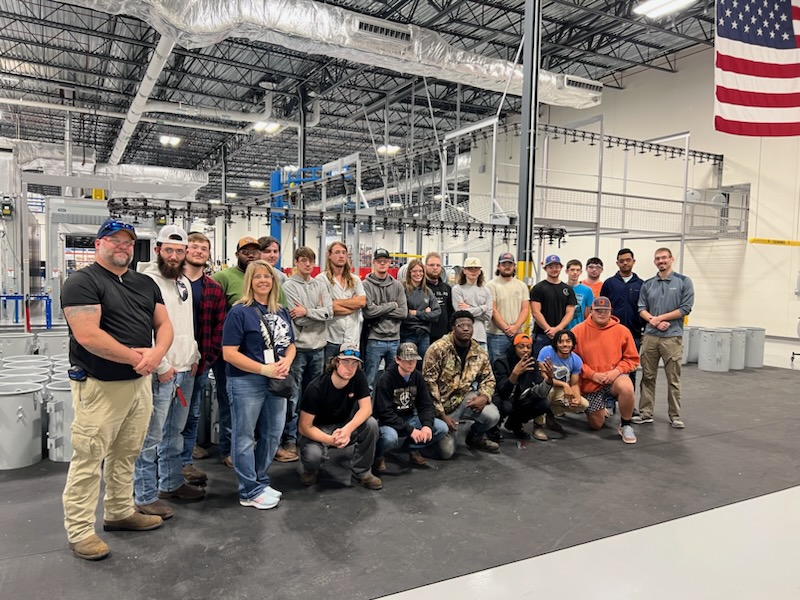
[714,0,800,136]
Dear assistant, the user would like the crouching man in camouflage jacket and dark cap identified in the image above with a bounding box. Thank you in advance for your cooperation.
[422,310,500,460]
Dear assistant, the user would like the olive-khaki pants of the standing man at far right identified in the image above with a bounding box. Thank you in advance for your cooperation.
[639,335,683,420]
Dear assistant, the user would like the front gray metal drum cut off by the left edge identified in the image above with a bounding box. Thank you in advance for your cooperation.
[0,383,42,470]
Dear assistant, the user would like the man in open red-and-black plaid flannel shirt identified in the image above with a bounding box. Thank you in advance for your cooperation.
[181,231,225,485]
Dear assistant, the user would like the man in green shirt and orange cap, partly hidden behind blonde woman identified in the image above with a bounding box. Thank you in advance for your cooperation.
[211,235,261,469]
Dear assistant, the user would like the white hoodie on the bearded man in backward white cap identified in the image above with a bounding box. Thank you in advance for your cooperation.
[136,262,200,375]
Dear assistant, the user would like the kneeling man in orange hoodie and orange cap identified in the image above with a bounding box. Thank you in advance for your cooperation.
[572,296,639,444]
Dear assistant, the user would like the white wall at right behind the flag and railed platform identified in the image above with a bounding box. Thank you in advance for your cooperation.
[516,49,800,337]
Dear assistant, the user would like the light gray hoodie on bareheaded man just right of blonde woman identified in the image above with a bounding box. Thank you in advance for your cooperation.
[281,273,333,350]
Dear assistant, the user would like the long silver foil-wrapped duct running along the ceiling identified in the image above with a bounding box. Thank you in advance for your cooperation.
[67,0,603,108]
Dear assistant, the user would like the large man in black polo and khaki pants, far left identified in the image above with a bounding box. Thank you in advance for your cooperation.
[61,219,173,560]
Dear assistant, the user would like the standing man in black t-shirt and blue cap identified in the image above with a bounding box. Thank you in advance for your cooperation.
[531,254,578,356]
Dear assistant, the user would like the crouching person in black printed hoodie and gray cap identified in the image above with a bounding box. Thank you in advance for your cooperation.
[374,342,448,473]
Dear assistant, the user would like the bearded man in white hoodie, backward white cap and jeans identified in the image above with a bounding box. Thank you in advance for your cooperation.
[133,225,205,519]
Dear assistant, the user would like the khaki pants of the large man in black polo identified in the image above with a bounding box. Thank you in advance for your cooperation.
[63,377,153,543]
